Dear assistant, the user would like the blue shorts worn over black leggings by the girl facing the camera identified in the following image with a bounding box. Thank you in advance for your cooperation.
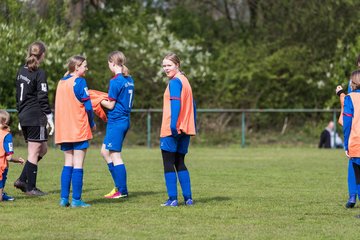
[160,135,190,154]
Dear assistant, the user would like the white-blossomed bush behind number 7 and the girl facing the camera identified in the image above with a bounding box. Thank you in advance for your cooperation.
[81,5,210,108]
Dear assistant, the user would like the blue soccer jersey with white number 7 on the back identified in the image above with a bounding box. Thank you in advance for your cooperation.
[108,74,134,123]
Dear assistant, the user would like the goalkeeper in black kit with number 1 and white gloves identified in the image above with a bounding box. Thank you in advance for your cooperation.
[14,41,54,196]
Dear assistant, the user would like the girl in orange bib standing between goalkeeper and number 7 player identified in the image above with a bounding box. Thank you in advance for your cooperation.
[55,56,96,207]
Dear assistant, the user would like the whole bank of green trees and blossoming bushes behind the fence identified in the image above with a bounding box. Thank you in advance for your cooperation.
[0,0,360,138]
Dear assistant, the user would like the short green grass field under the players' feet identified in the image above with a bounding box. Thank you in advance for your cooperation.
[0,147,360,239]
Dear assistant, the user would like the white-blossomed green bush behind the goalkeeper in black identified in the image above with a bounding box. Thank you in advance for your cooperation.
[0,0,88,108]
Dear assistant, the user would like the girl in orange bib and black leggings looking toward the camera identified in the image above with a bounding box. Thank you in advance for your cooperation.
[160,53,196,207]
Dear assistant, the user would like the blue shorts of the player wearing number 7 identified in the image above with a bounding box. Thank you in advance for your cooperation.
[104,120,130,152]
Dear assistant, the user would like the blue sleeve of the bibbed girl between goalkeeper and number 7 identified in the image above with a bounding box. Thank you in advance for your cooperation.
[74,78,95,128]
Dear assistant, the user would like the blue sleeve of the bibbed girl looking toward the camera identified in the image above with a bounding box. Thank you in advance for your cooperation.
[169,78,182,137]
